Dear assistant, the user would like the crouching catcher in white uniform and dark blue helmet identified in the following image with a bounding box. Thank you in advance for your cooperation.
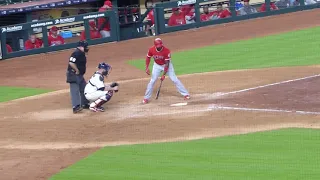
[84,62,119,112]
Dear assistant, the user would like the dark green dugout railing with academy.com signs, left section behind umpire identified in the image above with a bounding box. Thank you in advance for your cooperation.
[1,11,119,59]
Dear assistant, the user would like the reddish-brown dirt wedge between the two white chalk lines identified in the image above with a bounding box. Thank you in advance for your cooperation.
[217,74,320,115]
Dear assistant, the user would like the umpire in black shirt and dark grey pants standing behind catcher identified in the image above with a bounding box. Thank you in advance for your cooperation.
[67,41,89,113]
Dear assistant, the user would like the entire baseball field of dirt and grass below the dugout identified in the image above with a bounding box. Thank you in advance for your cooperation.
[0,9,320,180]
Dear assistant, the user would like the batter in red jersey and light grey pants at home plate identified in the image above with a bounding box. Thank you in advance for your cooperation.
[142,38,190,104]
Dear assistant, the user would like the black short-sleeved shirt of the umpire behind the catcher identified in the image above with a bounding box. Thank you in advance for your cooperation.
[68,48,87,75]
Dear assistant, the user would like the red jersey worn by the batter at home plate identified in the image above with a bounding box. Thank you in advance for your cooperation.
[147,46,171,65]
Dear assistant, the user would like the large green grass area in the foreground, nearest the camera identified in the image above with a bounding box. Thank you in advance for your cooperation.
[51,129,320,180]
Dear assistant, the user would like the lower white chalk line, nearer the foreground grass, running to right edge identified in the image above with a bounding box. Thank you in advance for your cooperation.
[209,106,320,115]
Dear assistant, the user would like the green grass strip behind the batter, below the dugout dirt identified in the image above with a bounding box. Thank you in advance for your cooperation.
[129,26,320,74]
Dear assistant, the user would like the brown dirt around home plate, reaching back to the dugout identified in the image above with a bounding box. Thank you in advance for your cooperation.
[0,10,320,180]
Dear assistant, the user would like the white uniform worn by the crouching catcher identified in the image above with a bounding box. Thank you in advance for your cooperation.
[84,72,113,102]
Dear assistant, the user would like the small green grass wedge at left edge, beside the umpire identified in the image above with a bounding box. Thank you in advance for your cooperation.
[0,86,49,102]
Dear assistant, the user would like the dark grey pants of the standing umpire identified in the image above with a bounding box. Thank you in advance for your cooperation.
[69,74,89,107]
